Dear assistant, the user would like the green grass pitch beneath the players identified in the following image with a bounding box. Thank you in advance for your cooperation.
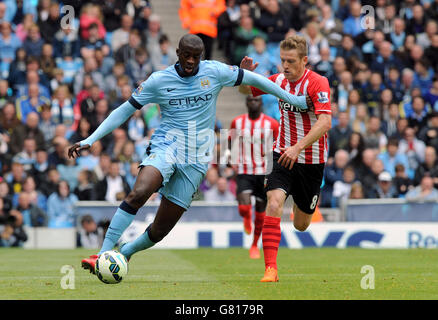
[0,248,438,300]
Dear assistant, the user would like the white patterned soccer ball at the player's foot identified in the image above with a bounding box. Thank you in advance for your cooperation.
[95,250,128,284]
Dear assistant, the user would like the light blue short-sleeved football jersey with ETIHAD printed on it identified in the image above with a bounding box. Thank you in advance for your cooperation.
[129,60,243,164]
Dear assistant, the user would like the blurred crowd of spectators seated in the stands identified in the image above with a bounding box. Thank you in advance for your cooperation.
[0,0,438,246]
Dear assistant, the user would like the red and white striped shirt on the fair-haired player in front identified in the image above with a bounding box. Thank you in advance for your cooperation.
[251,69,332,164]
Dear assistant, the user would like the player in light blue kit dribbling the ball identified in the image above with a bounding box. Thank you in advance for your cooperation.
[69,34,309,273]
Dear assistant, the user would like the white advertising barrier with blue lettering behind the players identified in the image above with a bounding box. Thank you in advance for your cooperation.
[24,221,438,249]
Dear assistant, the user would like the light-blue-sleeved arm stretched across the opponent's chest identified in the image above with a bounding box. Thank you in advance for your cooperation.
[242,69,308,110]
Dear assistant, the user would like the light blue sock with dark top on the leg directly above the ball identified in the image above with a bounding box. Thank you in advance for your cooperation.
[99,201,137,254]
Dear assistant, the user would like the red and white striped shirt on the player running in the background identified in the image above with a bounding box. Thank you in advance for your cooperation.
[230,113,279,175]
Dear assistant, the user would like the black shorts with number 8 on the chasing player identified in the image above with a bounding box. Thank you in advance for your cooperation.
[266,152,325,214]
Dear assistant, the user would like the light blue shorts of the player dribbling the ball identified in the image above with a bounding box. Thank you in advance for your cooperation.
[140,149,208,210]
